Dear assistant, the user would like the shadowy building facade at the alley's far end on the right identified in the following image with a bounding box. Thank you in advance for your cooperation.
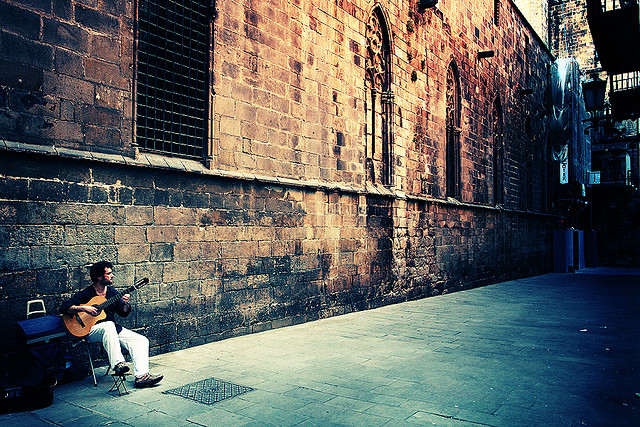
[549,0,640,267]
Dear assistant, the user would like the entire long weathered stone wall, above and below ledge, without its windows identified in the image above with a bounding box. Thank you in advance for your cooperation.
[0,0,552,360]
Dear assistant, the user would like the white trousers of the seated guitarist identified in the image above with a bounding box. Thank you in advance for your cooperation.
[87,321,149,378]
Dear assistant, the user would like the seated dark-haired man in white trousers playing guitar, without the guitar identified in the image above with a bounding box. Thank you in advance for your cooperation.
[59,261,162,387]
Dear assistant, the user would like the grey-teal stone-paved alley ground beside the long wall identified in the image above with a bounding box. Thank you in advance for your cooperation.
[0,268,640,426]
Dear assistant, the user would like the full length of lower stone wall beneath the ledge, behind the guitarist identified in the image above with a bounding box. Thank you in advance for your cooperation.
[0,151,549,352]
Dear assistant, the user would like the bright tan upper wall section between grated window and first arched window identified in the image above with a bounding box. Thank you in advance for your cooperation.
[213,0,367,185]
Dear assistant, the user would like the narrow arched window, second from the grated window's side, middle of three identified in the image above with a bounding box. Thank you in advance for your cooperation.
[445,62,460,197]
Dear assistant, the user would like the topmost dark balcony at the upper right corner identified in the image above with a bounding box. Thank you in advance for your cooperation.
[587,0,640,74]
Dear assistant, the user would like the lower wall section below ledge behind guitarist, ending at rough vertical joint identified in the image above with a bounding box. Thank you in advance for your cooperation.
[0,152,392,352]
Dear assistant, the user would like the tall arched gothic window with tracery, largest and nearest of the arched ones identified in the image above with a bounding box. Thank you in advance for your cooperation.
[365,7,394,185]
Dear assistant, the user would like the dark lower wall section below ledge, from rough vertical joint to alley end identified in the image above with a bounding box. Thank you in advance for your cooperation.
[396,200,551,296]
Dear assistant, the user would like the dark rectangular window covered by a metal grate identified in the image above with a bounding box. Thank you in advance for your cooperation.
[136,0,209,158]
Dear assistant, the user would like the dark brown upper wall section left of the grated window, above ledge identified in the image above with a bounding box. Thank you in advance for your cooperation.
[0,1,133,154]
